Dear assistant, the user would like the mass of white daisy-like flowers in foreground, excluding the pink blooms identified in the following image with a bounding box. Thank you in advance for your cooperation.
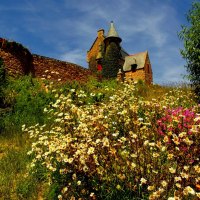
[22,84,200,199]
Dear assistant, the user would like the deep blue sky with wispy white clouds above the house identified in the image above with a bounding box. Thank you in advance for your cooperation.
[0,0,192,84]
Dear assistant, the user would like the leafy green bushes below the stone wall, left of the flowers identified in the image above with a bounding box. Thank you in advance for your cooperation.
[1,76,52,133]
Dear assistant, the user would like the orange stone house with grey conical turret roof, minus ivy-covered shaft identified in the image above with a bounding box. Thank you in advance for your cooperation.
[87,21,153,84]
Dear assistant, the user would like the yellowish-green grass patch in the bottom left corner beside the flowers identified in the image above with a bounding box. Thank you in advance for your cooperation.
[0,134,46,200]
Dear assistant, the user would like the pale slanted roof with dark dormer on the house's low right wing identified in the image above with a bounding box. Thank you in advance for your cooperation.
[123,51,148,72]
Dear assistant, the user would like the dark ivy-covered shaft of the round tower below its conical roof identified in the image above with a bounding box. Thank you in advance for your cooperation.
[102,42,120,78]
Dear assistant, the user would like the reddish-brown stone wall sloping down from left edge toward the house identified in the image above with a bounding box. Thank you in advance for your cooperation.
[0,38,91,82]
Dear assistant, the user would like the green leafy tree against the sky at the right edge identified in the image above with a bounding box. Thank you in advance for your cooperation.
[179,2,200,100]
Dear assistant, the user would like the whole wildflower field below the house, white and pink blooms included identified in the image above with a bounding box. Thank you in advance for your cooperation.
[0,77,200,200]
